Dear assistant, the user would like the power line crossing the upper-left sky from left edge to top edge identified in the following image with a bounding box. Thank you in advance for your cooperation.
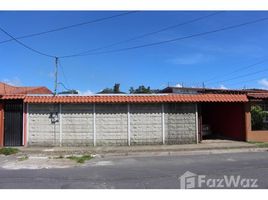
[0,11,138,44]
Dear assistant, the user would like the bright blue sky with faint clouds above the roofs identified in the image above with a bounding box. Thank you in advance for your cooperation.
[0,11,268,94]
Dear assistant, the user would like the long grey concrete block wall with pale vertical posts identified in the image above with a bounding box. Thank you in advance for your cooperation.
[28,103,197,146]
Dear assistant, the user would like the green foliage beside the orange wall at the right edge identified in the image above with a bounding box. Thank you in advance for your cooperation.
[251,105,266,130]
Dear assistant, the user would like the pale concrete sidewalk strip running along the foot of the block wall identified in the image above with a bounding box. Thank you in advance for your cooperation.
[16,140,264,157]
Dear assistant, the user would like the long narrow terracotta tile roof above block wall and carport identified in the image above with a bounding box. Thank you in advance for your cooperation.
[24,94,248,103]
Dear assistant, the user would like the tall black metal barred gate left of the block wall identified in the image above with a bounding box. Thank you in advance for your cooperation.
[4,102,23,146]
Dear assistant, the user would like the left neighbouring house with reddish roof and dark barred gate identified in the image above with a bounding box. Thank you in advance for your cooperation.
[0,83,52,146]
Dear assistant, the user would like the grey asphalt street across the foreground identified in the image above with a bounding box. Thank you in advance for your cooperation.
[0,152,268,189]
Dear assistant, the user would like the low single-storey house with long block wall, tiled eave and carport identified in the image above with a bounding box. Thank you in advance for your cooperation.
[0,83,268,146]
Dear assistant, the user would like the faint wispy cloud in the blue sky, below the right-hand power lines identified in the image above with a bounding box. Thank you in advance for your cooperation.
[168,53,212,65]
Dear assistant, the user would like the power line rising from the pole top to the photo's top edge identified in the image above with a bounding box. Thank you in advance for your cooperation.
[59,11,225,56]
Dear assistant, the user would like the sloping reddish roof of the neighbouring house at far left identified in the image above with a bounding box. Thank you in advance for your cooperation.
[0,82,52,95]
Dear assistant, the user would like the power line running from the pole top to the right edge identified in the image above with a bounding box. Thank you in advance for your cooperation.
[60,17,268,58]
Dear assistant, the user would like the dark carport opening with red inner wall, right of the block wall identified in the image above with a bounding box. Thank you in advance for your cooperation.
[199,103,245,141]
